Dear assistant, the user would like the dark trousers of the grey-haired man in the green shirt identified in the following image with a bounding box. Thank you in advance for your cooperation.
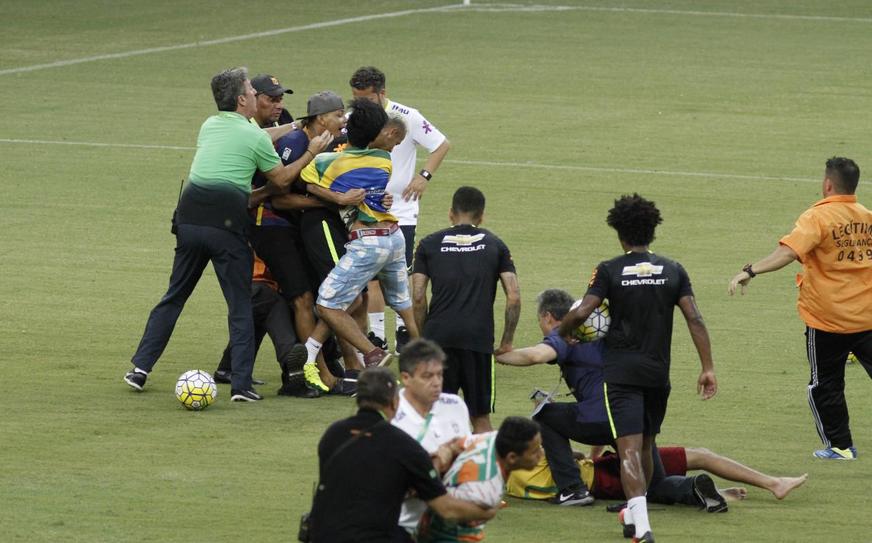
[132,224,254,390]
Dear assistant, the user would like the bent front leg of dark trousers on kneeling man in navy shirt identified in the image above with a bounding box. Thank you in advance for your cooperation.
[533,402,615,491]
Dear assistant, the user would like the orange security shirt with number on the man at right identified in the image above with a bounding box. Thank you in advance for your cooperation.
[780,194,872,333]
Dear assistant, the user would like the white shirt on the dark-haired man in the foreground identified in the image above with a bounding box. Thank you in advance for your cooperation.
[391,389,472,533]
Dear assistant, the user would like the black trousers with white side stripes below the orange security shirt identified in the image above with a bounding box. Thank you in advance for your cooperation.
[805,327,872,449]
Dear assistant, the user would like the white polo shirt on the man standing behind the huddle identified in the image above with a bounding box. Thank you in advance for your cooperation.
[385,100,445,226]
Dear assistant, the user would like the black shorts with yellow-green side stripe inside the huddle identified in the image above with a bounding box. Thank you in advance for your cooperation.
[300,208,348,286]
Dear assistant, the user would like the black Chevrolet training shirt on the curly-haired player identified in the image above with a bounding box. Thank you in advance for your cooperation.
[587,252,693,387]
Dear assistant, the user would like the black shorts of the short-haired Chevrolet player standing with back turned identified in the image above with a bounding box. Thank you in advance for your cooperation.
[442,347,496,417]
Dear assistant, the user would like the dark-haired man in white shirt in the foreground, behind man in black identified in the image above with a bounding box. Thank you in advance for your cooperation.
[391,339,471,541]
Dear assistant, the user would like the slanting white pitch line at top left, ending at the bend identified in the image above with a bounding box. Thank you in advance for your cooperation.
[0,4,462,76]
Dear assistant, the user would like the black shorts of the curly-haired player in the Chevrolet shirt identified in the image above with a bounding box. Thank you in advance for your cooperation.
[603,383,671,439]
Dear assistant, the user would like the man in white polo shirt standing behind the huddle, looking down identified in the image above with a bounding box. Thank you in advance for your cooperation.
[349,66,451,352]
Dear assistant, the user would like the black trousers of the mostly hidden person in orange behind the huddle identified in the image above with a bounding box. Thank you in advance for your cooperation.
[218,281,297,371]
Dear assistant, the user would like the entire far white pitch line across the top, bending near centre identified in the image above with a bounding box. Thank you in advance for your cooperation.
[0,4,872,76]
